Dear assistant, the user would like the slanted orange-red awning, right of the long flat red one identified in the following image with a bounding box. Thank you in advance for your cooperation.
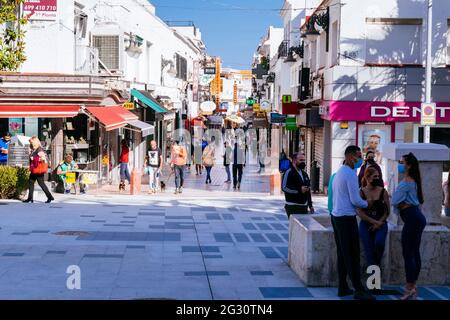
[86,106,139,131]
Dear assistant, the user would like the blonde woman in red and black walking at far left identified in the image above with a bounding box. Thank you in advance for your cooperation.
[23,136,55,203]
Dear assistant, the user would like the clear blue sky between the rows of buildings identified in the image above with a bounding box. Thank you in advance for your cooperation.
[150,0,284,69]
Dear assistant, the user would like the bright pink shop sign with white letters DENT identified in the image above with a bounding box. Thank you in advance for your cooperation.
[322,101,450,123]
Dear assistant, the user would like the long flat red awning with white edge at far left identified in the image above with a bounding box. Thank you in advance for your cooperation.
[0,105,80,118]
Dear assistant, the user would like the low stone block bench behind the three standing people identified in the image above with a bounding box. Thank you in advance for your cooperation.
[288,215,450,287]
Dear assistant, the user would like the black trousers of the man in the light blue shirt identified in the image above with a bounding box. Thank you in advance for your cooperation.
[331,215,364,291]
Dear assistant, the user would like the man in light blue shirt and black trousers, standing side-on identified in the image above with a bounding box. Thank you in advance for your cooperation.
[331,146,376,300]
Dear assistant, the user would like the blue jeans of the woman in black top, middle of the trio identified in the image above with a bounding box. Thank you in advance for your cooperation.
[359,221,388,266]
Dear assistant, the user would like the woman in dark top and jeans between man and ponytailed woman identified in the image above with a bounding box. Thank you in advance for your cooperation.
[357,167,390,274]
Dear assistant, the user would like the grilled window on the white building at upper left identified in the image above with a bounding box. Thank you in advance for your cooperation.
[92,35,120,70]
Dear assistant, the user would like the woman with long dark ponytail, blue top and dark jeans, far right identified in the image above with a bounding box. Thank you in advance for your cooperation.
[392,152,427,300]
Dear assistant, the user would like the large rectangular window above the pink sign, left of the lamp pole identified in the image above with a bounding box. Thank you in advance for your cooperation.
[366,18,422,65]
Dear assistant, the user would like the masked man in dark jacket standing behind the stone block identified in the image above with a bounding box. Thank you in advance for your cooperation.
[281,153,314,218]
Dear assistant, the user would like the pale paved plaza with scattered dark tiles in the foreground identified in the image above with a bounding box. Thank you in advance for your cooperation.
[0,191,450,300]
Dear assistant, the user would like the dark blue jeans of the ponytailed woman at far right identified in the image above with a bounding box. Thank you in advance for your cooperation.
[400,207,427,283]
